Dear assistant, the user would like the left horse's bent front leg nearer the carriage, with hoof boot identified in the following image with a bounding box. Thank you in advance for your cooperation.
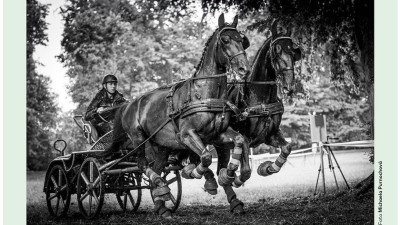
[182,129,218,195]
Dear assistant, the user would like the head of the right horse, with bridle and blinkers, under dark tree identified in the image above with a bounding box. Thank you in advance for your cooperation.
[269,20,301,96]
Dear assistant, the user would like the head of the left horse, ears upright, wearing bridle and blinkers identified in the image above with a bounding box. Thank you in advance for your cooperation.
[215,14,250,80]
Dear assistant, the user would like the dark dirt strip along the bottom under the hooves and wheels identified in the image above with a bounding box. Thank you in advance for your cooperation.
[28,192,373,225]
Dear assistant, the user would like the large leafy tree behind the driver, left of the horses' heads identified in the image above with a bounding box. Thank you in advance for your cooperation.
[59,0,212,113]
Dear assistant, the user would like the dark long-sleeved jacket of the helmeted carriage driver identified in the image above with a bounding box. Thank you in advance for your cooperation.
[85,88,126,122]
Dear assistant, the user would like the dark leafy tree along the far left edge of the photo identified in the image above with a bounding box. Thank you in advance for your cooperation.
[26,0,57,170]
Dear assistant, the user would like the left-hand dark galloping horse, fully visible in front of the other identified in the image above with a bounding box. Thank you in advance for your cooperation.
[106,14,251,217]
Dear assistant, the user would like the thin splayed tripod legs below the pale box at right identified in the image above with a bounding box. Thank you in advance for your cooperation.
[314,142,350,195]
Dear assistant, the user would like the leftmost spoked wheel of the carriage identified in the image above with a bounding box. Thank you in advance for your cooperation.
[45,165,71,218]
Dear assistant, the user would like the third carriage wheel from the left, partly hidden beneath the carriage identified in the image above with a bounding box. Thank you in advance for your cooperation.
[116,173,142,212]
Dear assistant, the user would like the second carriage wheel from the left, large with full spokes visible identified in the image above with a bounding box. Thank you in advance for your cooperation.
[77,157,104,219]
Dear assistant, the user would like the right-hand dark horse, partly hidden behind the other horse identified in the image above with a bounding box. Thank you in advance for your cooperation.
[215,21,301,200]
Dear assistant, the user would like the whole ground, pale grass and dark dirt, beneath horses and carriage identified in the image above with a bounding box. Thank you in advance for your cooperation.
[27,150,373,224]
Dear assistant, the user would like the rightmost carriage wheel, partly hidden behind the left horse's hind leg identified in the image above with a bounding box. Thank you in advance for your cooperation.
[150,170,182,212]
